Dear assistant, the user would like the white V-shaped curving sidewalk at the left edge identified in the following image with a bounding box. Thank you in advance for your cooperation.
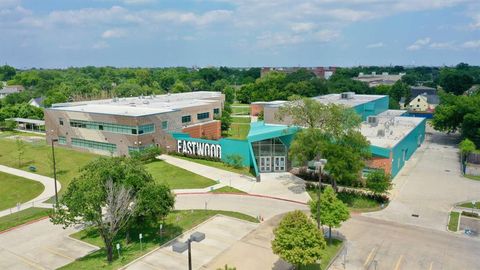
[0,165,62,217]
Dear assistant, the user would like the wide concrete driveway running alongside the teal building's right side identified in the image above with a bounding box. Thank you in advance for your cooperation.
[364,128,480,230]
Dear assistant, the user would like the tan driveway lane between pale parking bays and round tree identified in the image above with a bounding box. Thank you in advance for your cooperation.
[202,215,292,270]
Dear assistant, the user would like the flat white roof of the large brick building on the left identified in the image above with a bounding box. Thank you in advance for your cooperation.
[51,91,222,117]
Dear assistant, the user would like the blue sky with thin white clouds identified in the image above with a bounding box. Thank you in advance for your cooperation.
[0,0,480,68]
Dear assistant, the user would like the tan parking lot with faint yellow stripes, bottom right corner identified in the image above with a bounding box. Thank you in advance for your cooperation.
[330,216,480,270]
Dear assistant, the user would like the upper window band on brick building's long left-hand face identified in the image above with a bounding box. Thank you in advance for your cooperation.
[70,119,155,134]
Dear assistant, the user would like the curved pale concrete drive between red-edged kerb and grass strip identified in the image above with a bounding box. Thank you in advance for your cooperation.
[175,193,309,220]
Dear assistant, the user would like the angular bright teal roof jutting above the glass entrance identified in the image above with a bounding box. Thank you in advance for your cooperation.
[247,121,299,142]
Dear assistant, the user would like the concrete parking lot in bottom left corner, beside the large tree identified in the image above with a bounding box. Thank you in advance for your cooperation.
[0,219,97,270]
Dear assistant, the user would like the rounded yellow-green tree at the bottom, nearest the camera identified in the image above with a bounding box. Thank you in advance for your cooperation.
[272,210,326,267]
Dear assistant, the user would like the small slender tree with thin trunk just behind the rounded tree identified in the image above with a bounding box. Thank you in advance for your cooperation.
[309,186,350,244]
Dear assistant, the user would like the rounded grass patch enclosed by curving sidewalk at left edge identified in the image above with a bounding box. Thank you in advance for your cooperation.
[0,172,45,210]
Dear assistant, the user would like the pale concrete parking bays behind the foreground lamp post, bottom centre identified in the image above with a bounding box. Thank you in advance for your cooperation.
[123,215,259,270]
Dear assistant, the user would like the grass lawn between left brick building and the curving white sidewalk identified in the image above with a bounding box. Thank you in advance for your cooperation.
[0,132,100,198]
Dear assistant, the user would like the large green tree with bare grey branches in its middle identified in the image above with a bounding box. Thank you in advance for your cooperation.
[51,157,174,262]
